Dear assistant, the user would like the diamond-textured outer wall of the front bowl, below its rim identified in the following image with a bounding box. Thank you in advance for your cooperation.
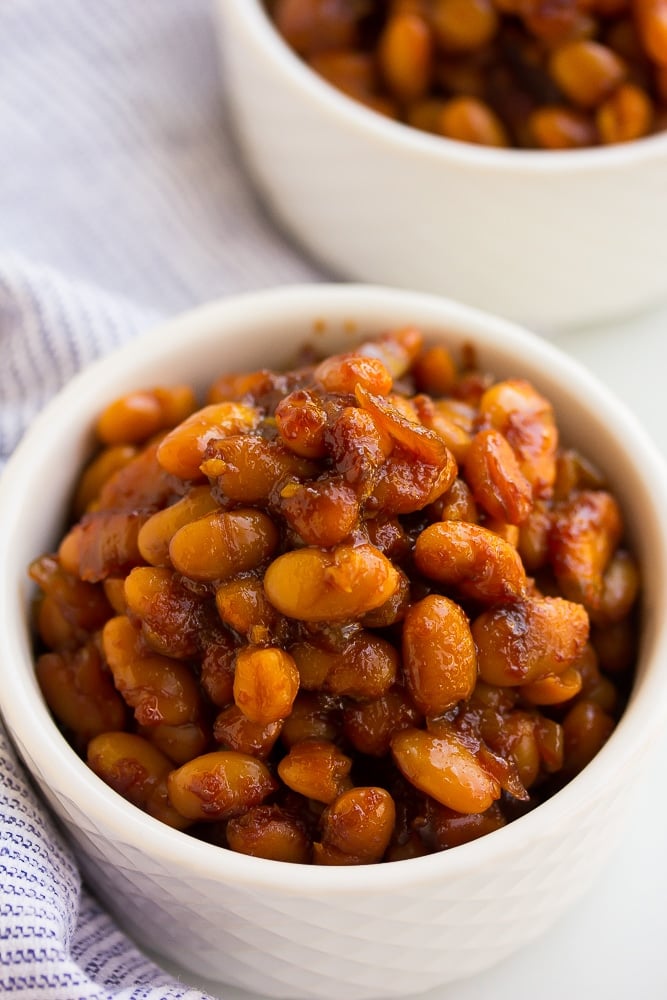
[13,728,621,1000]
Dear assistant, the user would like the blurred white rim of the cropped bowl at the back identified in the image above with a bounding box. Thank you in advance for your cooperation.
[217,0,667,175]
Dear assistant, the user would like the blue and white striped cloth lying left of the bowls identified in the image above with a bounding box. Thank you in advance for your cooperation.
[0,0,320,1000]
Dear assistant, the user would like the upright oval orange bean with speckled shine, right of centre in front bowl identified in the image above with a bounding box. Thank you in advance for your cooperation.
[403,594,477,715]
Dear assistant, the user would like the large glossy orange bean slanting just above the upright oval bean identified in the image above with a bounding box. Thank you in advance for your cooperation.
[414,521,527,603]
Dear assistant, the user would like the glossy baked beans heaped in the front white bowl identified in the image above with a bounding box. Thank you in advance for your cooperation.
[30,327,639,865]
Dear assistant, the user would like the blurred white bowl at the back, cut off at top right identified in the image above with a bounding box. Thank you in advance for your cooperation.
[216,0,667,334]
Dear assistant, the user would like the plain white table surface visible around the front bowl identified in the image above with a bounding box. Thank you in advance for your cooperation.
[163,304,667,1000]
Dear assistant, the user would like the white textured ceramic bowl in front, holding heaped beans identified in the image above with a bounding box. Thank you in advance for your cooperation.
[0,286,667,1000]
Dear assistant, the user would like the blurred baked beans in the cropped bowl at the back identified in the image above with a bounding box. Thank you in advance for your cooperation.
[267,0,667,150]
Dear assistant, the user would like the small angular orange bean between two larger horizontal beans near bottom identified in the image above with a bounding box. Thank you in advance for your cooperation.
[278,739,352,804]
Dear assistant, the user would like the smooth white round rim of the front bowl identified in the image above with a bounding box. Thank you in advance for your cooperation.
[0,284,667,897]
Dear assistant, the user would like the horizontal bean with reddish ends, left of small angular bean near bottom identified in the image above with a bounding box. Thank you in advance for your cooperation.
[167,750,277,821]
